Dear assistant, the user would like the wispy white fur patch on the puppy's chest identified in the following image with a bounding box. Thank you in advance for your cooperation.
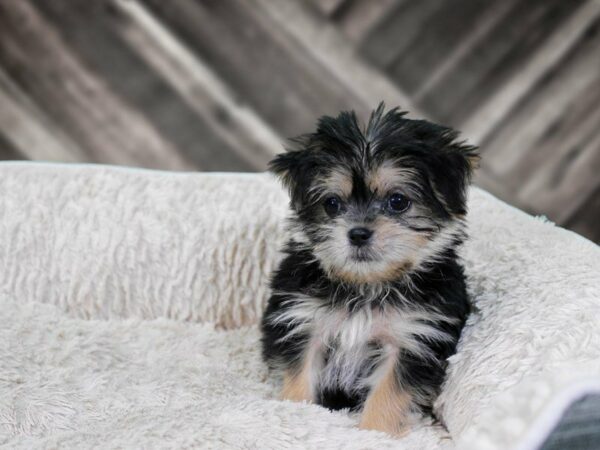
[275,296,451,391]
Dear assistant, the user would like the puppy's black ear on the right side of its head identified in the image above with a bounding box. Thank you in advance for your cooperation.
[430,142,480,215]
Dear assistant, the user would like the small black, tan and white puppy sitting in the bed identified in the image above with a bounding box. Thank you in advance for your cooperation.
[262,104,478,435]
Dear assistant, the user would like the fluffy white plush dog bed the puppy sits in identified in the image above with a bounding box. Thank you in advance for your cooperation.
[0,163,600,449]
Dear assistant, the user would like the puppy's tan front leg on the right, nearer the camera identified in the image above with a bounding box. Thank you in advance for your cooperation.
[359,358,412,436]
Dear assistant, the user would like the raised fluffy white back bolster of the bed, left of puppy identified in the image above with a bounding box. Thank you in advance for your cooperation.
[0,163,287,328]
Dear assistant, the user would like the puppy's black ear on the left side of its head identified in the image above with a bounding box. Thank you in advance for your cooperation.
[269,150,315,209]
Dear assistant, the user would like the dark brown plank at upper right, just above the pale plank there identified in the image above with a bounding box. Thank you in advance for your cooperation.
[419,0,581,126]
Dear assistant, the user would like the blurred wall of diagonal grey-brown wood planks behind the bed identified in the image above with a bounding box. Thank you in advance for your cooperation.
[0,0,600,242]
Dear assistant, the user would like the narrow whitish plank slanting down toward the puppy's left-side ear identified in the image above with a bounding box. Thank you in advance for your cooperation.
[115,1,282,170]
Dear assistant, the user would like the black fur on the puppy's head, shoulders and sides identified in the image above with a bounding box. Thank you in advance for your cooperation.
[262,105,477,424]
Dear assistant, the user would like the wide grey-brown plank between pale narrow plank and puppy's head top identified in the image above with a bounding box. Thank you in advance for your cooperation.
[144,0,370,137]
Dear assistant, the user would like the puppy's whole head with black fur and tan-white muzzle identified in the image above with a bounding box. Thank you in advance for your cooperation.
[271,106,476,283]
